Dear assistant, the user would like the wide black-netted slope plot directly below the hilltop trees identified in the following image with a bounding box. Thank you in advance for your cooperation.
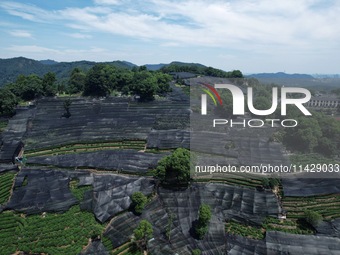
[25,98,189,152]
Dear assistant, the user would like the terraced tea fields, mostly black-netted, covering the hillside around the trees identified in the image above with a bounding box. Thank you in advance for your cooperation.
[0,82,340,255]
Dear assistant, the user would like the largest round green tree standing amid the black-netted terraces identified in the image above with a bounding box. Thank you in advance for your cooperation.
[156,148,190,185]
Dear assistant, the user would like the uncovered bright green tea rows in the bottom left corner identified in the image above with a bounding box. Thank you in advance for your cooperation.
[0,205,105,255]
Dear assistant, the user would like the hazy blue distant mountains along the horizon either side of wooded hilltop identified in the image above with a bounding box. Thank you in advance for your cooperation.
[0,57,339,87]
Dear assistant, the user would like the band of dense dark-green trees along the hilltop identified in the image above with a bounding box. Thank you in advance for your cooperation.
[0,64,243,116]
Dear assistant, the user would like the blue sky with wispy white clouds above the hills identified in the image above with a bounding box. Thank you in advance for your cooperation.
[0,0,340,74]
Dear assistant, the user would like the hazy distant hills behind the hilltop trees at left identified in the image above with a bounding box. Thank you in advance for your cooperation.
[0,57,135,87]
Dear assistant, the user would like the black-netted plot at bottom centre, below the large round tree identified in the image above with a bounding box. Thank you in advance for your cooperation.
[104,184,280,255]
